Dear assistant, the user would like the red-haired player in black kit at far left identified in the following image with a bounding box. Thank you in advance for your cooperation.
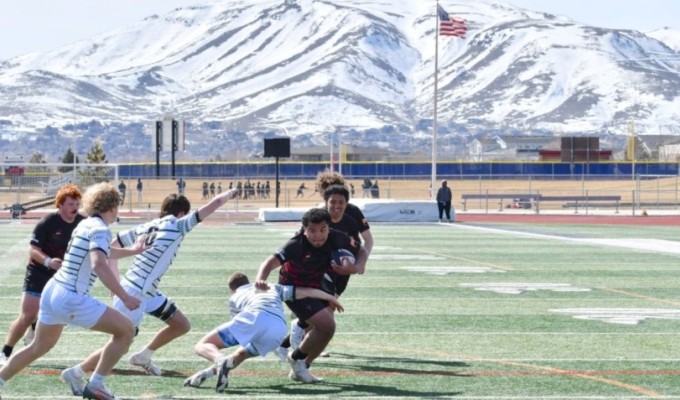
[0,184,85,367]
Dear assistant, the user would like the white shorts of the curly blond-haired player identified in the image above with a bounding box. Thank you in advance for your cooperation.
[38,279,107,329]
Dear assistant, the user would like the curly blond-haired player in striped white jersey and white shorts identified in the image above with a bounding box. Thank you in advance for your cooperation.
[0,182,145,400]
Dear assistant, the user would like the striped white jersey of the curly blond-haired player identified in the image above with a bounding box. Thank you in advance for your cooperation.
[52,215,112,294]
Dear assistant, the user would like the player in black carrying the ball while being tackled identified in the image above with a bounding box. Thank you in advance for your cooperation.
[255,208,368,383]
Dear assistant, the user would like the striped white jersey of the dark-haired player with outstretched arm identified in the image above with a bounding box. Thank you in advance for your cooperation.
[117,211,199,298]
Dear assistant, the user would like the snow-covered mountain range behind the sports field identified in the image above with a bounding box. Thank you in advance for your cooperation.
[0,0,680,141]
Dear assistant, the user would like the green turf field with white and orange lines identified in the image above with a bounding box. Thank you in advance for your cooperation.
[0,222,680,400]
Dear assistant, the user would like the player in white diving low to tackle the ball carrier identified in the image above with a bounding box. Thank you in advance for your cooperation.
[184,272,344,393]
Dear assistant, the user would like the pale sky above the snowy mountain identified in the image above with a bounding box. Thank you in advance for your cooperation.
[0,0,680,59]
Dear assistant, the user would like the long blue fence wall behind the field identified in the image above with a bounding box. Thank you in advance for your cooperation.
[119,161,680,179]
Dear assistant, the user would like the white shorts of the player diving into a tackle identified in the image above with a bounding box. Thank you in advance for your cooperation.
[217,311,288,357]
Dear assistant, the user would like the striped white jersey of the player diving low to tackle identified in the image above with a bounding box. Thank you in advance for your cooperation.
[229,283,295,322]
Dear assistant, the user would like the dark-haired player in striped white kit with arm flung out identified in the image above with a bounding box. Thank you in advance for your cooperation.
[62,190,237,395]
